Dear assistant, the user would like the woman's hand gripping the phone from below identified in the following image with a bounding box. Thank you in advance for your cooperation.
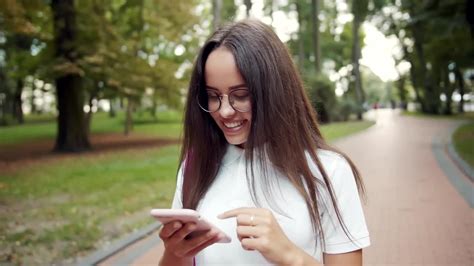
[159,221,220,265]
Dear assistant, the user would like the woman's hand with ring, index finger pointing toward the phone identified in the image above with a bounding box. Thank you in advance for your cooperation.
[218,208,318,265]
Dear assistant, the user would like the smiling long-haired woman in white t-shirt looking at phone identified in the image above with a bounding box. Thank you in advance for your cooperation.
[160,20,370,265]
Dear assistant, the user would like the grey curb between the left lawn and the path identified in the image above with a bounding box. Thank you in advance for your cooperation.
[76,222,161,266]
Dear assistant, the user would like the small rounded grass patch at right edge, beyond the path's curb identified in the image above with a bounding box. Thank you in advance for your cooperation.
[453,123,474,167]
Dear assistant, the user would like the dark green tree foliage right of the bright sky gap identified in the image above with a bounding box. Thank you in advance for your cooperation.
[379,0,474,114]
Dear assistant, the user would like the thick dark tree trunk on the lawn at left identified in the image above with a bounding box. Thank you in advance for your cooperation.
[51,0,90,152]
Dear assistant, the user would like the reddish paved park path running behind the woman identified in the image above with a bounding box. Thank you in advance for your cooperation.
[94,110,474,266]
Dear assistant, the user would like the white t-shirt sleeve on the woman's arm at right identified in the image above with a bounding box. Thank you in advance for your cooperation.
[321,156,370,254]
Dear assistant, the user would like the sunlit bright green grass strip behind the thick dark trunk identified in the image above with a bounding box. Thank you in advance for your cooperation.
[0,111,181,145]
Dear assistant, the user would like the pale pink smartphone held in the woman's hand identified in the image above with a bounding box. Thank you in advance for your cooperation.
[150,209,231,243]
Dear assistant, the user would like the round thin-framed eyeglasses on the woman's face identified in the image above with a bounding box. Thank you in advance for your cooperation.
[198,89,252,113]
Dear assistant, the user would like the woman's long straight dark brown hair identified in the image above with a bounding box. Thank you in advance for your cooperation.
[180,20,364,248]
